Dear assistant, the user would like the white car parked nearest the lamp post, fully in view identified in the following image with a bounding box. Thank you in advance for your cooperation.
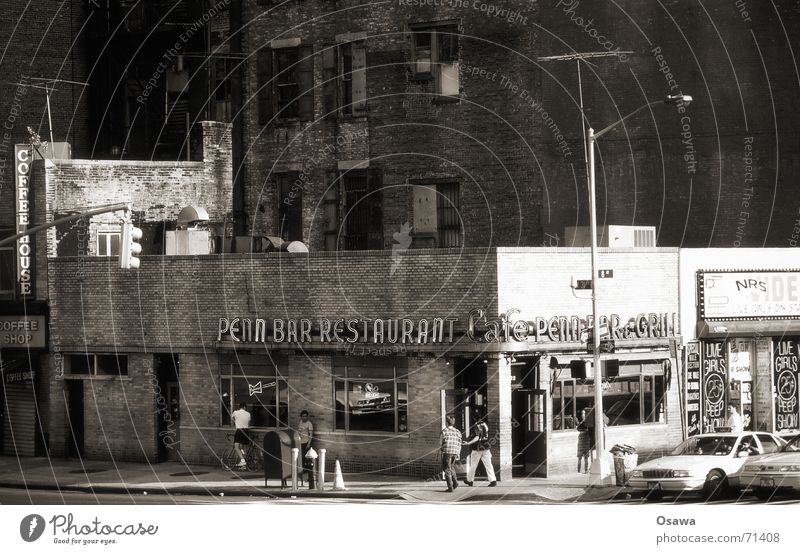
[629,432,785,499]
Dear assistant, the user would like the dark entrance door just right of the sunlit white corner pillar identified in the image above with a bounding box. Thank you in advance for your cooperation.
[511,389,547,477]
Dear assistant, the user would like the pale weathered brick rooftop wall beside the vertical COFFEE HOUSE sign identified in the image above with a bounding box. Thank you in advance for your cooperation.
[33,121,232,256]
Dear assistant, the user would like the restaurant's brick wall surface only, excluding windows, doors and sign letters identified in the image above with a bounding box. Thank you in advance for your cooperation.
[47,249,681,479]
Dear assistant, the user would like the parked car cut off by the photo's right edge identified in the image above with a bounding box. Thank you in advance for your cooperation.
[741,435,800,500]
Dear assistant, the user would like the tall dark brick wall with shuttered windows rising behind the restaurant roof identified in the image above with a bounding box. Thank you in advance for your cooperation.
[244,0,540,246]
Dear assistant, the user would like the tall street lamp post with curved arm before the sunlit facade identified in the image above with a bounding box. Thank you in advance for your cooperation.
[586,94,692,478]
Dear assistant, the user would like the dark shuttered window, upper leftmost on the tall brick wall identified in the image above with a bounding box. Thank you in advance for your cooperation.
[256,46,314,125]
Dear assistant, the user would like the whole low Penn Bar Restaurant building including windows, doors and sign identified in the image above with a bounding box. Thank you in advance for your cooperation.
[45,249,682,479]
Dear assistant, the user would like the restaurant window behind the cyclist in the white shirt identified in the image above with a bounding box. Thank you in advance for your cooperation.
[219,358,289,427]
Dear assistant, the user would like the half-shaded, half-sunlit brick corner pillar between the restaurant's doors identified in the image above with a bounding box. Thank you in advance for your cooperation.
[486,357,512,481]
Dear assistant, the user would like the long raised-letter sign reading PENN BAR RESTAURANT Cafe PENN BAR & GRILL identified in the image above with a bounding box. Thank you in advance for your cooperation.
[217,308,678,345]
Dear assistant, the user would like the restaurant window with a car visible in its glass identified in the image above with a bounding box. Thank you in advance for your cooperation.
[333,357,408,433]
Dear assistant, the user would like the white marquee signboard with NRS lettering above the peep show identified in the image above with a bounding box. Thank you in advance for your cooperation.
[698,270,800,321]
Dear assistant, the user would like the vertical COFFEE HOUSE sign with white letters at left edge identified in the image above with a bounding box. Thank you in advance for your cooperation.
[14,144,36,298]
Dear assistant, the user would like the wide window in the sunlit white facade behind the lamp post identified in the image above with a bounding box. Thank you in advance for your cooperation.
[553,360,667,431]
